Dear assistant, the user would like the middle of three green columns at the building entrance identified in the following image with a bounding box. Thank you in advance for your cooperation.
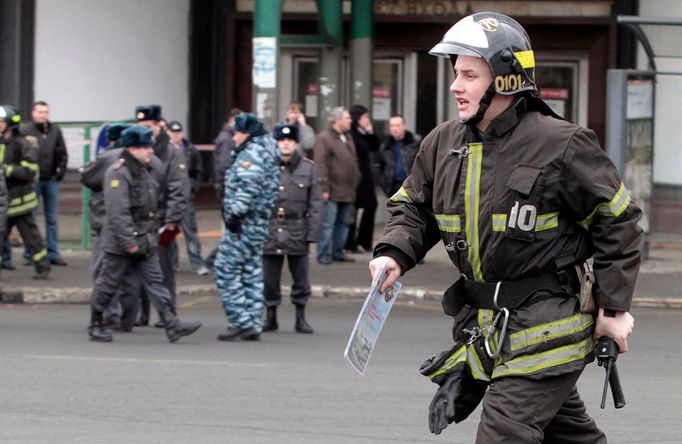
[317,0,343,125]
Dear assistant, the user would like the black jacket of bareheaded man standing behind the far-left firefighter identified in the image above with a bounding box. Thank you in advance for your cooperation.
[21,121,69,181]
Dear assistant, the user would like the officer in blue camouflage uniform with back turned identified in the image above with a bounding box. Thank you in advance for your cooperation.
[215,113,279,341]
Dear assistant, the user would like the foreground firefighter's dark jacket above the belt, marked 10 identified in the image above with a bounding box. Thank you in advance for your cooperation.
[375,98,643,311]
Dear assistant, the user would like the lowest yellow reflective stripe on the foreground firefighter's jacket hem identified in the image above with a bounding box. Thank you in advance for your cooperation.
[492,337,594,379]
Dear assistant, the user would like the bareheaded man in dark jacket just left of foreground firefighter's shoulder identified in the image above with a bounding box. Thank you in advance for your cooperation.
[379,114,422,198]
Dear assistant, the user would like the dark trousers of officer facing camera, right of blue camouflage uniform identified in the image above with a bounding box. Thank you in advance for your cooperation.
[263,254,312,307]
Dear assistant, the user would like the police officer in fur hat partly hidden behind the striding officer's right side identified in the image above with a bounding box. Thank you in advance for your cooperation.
[135,105,191,327]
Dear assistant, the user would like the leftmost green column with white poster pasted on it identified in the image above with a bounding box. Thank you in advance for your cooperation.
[251,0,282,128]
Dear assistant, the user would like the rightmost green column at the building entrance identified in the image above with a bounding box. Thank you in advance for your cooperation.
[350,0,374,109]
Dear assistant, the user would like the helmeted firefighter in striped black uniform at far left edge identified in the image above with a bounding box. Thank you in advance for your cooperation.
[0,105,50,279]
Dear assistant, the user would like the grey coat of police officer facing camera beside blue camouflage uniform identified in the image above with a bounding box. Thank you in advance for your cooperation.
[263,153,323,255]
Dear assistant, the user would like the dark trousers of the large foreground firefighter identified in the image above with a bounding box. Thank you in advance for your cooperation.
[476,371,606,444]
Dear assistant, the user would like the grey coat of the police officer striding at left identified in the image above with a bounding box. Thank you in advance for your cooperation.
[102,150,158,255]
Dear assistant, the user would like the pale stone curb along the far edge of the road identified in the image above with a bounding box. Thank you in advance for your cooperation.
[0,284,682,310]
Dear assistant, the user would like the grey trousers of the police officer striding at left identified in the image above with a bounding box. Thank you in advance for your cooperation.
[92,253,173,313]
